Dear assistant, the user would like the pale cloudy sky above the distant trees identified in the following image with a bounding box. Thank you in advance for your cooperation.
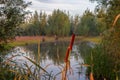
[25,0,97,15]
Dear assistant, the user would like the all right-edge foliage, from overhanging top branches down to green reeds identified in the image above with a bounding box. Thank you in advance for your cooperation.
[84,0,120,80]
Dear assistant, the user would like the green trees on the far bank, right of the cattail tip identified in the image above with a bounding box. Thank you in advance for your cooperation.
[75,9,106,36]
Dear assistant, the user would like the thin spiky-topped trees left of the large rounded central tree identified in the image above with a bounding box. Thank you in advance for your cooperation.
[21,11,47,36]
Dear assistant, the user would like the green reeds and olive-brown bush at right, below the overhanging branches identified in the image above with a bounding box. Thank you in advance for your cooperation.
[87,14,120,80]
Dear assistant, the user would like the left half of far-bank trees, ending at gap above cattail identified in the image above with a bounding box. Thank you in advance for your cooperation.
[22,9,70,36]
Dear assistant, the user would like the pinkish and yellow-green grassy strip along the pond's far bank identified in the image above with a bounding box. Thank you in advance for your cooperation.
[9,36,101,46]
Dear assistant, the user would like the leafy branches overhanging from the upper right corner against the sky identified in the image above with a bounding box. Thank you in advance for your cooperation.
[90,0,120,28]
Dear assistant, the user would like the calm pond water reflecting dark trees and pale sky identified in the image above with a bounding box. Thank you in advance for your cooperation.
[6,42,94,80]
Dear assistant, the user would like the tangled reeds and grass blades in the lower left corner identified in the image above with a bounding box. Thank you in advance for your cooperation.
[0,55,57,80]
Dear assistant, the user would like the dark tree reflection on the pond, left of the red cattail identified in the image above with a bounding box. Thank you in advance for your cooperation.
[26,42,68,65]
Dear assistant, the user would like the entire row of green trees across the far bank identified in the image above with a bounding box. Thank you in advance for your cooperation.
[17,9,106,36]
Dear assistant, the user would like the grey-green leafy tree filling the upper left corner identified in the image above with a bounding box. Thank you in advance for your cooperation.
[0,0,31,46]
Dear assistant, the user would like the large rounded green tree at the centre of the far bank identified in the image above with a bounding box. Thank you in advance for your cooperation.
[46,9,70,36]
